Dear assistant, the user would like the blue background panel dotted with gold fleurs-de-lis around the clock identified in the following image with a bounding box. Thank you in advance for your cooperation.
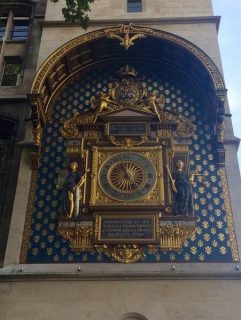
[27,65,237,263]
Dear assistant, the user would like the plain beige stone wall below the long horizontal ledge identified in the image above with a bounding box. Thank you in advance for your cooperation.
[0,280,241,320]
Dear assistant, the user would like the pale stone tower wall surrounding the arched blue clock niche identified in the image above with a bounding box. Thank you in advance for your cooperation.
[0,0,241,320]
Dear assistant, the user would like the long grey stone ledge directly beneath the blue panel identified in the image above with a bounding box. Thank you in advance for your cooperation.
[0,263,241,282]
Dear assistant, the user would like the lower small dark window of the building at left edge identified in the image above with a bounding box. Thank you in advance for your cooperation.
[1,57,22,86]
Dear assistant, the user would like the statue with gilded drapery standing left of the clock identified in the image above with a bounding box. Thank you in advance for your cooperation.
[62,161,85,218]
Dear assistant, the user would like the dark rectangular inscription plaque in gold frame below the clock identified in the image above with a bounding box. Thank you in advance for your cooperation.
[96,214,157,243]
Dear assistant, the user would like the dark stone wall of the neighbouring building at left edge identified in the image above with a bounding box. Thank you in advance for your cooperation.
[0,0,46,265]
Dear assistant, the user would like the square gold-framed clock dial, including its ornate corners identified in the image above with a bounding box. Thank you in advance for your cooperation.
[91,147,164,206]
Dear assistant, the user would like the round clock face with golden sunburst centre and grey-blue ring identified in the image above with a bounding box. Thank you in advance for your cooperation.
[99,152,156,201]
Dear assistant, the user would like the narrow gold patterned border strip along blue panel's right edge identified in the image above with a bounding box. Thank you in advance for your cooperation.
[219,168,240,262]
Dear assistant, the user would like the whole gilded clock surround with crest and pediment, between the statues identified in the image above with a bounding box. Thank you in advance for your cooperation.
[58,66,196,263]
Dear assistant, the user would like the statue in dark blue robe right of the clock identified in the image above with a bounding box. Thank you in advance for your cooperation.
[167,160,195,217]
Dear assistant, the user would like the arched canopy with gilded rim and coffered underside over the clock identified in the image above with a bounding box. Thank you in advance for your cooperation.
[30,24,226,168]
